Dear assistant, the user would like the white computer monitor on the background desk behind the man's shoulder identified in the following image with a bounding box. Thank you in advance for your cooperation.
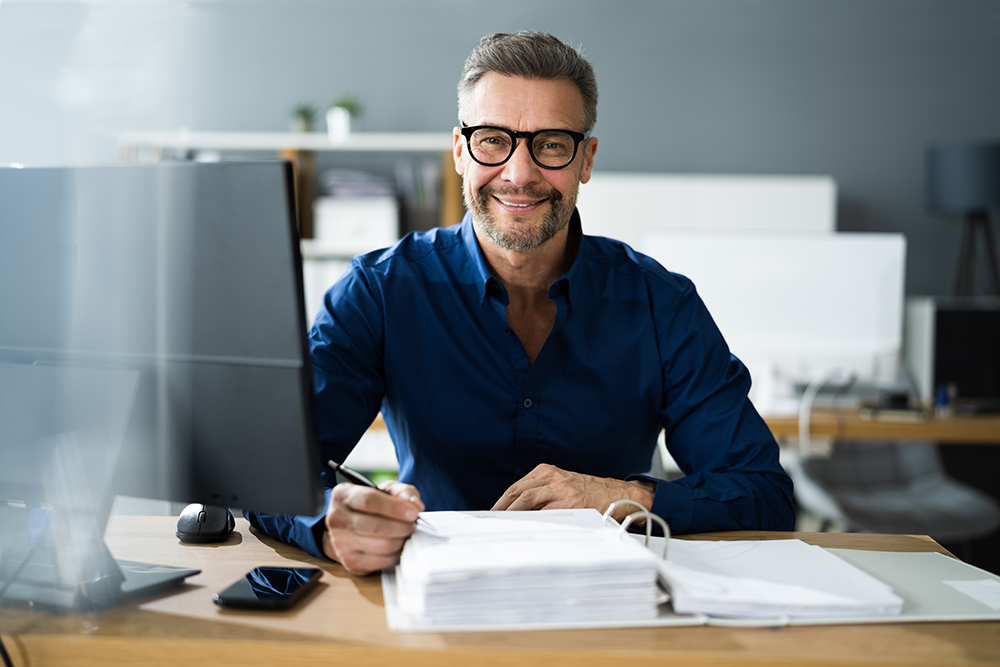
[639,230,906,414]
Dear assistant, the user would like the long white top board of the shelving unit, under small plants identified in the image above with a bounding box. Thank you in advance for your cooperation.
[118,130,453,153]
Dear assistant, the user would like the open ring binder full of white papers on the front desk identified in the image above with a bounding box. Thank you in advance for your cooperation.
[382,510,1000,632]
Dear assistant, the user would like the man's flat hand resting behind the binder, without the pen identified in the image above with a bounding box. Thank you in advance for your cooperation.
[493,463,656,521]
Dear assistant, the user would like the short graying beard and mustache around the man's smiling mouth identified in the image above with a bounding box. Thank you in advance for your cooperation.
[462,181,576,252]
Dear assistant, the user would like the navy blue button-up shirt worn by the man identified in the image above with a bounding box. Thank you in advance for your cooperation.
[248,213,794,555]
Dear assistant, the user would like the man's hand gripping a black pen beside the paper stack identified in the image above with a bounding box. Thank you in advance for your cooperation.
[323,482,424,575]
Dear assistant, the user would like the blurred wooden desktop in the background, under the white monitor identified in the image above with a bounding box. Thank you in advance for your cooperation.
[764,410,1000,445]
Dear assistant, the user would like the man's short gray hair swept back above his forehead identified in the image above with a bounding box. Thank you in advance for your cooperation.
[458,30,597,132]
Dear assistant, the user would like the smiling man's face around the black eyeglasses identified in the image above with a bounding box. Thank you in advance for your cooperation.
[454,72,597,252]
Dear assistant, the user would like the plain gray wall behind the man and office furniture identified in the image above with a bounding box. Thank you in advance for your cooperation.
[0,0,1000,294]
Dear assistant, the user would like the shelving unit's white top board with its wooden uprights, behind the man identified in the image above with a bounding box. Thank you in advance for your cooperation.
[118,130,464,238]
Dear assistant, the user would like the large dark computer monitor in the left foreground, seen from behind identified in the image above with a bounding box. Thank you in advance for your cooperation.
[0,161,322,606]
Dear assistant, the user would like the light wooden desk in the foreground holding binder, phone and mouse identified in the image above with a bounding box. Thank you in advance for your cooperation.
[0,516,1000,667]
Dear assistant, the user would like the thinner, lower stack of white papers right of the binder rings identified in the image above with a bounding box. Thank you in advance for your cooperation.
[660,540,903,619]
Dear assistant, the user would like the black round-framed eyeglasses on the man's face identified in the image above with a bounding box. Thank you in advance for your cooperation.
[462,123,590,169]
